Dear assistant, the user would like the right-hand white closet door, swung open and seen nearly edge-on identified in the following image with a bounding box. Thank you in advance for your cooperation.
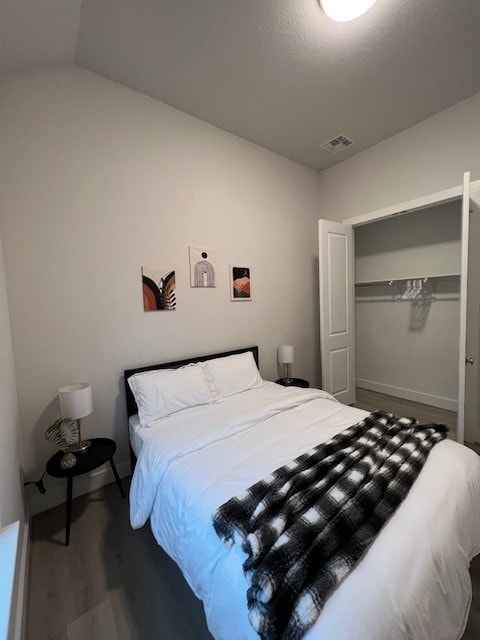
[459,180,480,442]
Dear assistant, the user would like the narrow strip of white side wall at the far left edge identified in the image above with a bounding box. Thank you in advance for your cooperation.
[0,232,23,529]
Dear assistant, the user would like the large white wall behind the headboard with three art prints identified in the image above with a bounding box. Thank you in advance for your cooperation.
[0,68,318,504]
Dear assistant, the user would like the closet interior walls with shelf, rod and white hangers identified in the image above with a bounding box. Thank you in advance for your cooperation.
[355,201,461,411]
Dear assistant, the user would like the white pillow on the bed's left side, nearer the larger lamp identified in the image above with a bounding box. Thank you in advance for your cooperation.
[128,363,218,427]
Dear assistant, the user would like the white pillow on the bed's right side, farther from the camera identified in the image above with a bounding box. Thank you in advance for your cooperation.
[203,351,263,398]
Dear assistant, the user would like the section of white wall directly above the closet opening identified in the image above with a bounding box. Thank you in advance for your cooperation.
[318,94,480,220]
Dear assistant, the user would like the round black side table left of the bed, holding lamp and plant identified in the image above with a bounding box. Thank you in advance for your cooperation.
[47,438,125,547]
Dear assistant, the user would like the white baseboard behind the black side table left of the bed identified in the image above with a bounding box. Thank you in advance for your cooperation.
[27,460,131,516]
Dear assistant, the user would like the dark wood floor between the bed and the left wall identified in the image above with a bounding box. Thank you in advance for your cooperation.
[26,483,213,640]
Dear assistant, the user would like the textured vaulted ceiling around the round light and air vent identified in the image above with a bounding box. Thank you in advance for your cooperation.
[0,0,480,170]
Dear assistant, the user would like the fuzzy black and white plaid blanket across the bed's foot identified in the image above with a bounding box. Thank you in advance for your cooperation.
[213,411,448,640]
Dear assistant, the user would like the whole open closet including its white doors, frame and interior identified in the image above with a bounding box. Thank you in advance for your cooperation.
[318,172,480,443]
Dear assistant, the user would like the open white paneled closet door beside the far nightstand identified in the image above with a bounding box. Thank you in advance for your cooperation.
[318,220,356,404]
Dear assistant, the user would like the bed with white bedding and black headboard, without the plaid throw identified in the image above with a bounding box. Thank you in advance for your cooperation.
[125,347,480,640]
